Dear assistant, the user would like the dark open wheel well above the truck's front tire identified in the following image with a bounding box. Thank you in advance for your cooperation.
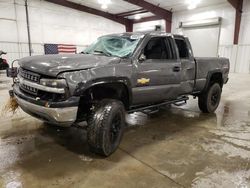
[77,83,130,119]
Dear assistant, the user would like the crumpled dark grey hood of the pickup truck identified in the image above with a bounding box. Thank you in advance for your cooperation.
[19,54,120,77]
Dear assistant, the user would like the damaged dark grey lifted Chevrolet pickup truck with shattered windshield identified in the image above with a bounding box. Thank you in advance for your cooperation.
[8,32,229,156]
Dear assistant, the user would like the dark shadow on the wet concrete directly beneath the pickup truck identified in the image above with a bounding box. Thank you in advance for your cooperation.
[40,108,216,159]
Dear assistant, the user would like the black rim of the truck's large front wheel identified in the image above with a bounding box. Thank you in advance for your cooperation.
[110,114,121,144]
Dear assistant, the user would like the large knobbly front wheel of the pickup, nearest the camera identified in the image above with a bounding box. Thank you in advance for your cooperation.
[87,99,125,156]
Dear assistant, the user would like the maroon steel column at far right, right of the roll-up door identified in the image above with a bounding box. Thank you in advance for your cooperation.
[228,0,243,44]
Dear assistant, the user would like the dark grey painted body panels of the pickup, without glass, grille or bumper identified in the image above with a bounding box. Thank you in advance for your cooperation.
[12,32,229,125]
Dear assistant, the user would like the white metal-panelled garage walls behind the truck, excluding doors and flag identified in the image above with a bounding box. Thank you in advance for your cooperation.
[0,0,250,73]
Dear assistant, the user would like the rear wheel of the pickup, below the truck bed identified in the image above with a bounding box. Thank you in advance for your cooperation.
[198,83,221,113]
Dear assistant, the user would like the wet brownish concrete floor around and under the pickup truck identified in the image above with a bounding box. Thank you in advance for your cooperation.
[0,71,250,188]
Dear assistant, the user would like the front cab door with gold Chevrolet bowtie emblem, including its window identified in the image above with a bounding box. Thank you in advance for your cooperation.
[133,35,181,104]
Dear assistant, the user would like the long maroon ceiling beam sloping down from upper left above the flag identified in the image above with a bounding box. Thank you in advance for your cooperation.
[45,0,131,26]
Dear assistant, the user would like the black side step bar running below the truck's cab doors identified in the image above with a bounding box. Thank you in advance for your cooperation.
[127,96,189,113]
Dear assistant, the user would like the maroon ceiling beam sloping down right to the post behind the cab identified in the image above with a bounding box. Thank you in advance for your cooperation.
[124,0,172,22]
